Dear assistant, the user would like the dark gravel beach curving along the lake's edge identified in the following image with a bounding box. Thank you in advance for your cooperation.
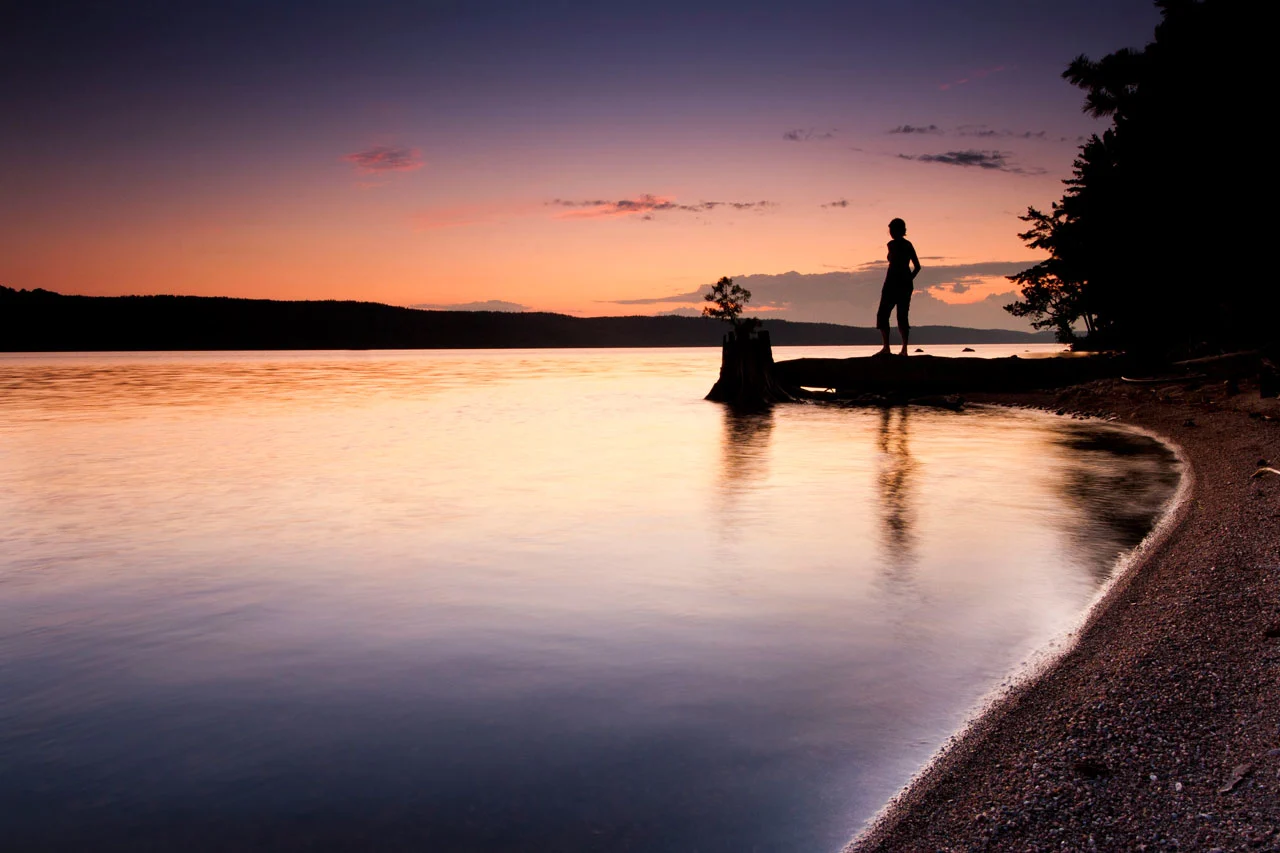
[847,380,1280,853]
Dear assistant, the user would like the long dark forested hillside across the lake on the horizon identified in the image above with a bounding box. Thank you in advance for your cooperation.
[0,287,1052,352]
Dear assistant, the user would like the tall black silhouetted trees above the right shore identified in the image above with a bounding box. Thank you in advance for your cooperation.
[1006,0,1280,356]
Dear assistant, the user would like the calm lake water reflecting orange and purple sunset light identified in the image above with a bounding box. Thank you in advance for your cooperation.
[0,347,1178,853]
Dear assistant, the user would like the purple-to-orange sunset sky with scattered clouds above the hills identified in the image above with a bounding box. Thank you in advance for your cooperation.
[0,0,1158,328]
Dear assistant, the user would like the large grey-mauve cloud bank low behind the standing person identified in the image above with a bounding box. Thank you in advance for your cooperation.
[611,261,1032,330]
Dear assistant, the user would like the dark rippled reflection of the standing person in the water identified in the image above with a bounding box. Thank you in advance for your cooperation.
[876,406,918,580]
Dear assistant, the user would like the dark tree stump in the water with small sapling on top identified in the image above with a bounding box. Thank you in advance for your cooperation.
[703,277,795,410]
